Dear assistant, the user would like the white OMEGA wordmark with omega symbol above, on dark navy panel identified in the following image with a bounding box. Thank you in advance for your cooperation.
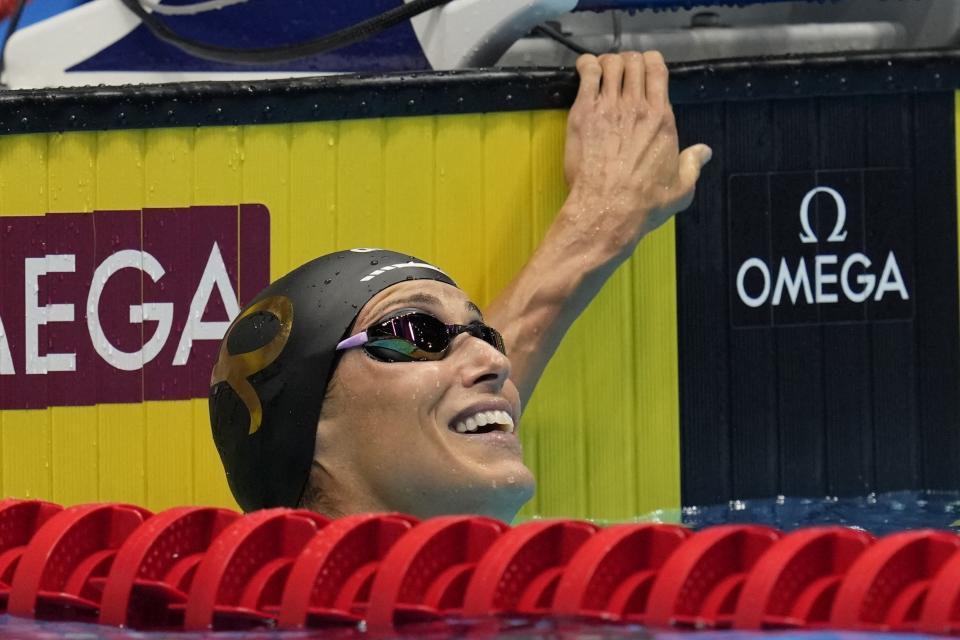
[736,187,910,308]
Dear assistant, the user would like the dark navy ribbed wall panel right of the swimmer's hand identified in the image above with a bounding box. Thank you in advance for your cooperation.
[677,92,960,504]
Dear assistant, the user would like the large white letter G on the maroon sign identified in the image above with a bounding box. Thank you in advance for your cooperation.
[87,249,173,371]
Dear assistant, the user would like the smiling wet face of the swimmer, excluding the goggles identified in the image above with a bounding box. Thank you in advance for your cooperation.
[307,280,534,521]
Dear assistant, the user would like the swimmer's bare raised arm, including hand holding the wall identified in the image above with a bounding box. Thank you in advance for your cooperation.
[484,52,711,402]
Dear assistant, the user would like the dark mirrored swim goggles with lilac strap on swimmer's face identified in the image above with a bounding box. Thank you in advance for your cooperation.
[337,311,507,362]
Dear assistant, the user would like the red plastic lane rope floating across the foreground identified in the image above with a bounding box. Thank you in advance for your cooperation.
[0,500,960,635]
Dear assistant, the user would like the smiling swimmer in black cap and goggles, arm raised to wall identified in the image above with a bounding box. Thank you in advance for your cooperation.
[210,52,711,522]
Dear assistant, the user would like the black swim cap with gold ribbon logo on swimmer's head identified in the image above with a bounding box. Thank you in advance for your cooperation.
[210,249,456,511]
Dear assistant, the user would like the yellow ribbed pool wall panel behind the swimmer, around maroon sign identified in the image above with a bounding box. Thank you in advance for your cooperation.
[0,111,680,520]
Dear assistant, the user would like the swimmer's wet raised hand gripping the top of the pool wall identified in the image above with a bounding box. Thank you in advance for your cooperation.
[561,51,712,260]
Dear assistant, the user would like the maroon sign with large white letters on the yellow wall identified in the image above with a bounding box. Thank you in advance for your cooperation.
[0,204,270,409]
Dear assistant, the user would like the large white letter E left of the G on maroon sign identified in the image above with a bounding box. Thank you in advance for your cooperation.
[25,253,77,374]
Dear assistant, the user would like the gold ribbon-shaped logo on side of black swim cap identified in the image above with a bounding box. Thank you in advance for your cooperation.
[210,296,293,435]
